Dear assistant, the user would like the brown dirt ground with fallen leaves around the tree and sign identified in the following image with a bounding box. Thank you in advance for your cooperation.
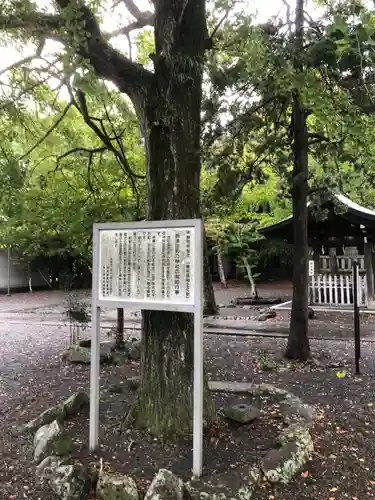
[0,283,375,500]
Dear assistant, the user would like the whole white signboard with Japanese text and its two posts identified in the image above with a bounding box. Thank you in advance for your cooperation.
[90,219,203,477]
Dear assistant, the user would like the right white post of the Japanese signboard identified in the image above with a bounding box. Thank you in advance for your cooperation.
[193,221,204,477]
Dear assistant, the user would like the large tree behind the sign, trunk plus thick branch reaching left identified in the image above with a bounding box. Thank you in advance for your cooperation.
[0,0,219,434]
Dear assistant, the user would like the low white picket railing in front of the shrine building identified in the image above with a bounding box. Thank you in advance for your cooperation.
[309,274,367,307]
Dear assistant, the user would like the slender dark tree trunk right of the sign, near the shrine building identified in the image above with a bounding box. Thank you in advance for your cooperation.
[285,0,310,360]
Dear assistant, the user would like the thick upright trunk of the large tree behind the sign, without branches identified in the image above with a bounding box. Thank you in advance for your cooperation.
[129,0,214,435]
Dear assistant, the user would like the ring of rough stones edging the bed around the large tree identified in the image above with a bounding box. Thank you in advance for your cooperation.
[27,381,314,500]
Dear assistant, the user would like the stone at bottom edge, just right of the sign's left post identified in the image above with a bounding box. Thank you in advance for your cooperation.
[96,472,139,500]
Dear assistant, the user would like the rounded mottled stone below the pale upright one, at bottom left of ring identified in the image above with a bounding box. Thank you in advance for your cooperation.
[36,456,91,500]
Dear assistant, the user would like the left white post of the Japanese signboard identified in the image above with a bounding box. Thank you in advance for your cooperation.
[89,226,100,450]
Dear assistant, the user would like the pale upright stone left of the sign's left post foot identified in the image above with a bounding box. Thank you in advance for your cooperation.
[34,420,73,463]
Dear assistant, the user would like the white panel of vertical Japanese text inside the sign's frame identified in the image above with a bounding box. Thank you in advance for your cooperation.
[99,227,195,306]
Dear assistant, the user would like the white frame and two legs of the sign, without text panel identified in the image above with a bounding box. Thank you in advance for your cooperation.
[89,219,204,477]
